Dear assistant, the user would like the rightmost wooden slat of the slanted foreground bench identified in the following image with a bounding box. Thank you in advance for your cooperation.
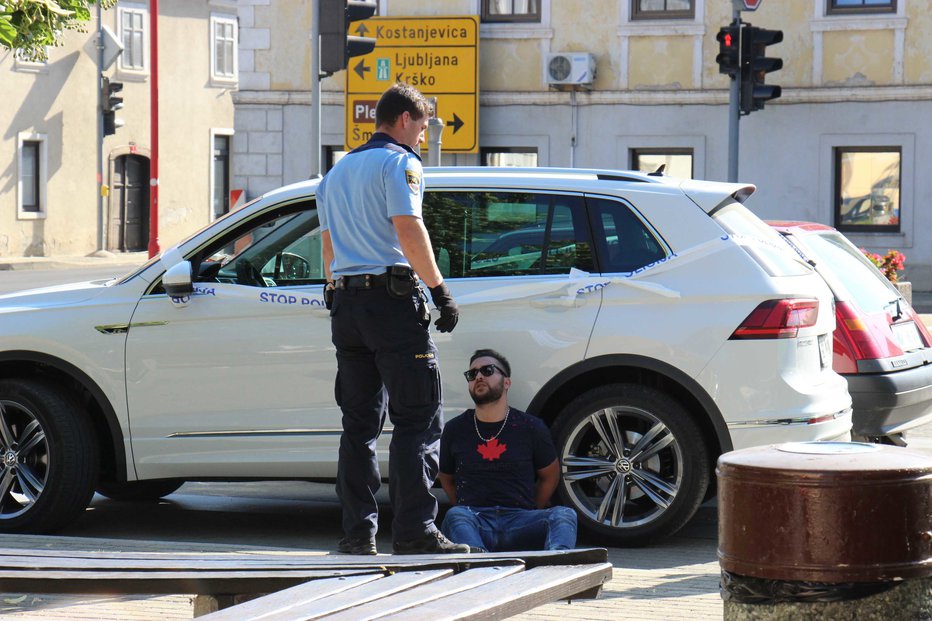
[378,563,612,621]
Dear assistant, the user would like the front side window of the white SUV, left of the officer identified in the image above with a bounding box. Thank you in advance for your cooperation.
[197,203,325,287]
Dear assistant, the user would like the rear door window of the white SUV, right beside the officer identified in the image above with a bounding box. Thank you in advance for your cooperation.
[424,191,592,278]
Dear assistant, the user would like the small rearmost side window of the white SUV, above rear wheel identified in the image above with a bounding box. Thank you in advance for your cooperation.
[586,196,666,272]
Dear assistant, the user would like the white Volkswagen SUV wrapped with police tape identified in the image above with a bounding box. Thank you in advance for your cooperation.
[0,168,851,544]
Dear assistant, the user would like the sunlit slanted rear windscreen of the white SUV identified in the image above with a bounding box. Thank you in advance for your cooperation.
[712,202,812,276]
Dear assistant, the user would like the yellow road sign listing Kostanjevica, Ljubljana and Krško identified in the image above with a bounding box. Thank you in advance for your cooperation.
[345,15,479,153]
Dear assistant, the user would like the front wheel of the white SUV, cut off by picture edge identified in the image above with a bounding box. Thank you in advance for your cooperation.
[0,379,99,533]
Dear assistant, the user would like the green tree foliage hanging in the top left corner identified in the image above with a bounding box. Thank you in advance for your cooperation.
[0,0,117,61]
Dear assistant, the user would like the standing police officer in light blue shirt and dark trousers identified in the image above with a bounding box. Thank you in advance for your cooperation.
[317,83,469,554]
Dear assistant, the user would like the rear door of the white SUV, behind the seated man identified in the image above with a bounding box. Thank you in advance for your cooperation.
[424,188,601,418]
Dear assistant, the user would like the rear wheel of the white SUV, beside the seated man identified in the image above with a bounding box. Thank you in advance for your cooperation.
[553,384,710,546]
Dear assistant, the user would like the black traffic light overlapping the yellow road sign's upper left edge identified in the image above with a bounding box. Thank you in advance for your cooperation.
[318,0,378,75]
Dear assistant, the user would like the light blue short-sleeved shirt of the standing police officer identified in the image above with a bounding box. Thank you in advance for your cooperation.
[317,133,424,280]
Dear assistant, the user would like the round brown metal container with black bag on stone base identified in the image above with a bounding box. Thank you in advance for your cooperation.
[716,442,932,621]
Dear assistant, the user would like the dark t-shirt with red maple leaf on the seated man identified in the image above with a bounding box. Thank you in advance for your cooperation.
[440,408,557,509]
